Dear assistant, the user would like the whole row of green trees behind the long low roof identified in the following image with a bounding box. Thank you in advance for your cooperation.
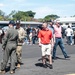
[0,10,61,22]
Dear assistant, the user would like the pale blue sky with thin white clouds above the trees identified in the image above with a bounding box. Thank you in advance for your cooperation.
[0,0,75,18]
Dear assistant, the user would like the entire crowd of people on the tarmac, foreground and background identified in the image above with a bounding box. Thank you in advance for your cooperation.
[0,20,75,74]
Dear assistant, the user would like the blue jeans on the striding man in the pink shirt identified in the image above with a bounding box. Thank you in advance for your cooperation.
[53,38,67,58]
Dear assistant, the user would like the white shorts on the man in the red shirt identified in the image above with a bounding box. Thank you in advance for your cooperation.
[41,44,52,56]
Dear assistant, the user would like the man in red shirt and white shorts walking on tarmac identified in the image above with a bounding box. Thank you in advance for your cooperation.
[38,23,53,69]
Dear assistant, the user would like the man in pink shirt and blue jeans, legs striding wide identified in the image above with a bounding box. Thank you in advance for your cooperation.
[53,22,69,59]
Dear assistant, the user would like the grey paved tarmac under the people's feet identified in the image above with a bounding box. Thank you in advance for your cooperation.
[0,44,75,75]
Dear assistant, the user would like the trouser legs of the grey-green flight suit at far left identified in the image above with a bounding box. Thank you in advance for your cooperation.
[1,44,16,70]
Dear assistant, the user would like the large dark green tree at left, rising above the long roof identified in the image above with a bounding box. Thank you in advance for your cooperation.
[12,11,35,21]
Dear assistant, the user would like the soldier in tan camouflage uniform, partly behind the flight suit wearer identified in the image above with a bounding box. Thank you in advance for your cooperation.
[16,20,26,68]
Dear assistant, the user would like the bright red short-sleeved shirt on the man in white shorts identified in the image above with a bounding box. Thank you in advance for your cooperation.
[38,29,52,44]
